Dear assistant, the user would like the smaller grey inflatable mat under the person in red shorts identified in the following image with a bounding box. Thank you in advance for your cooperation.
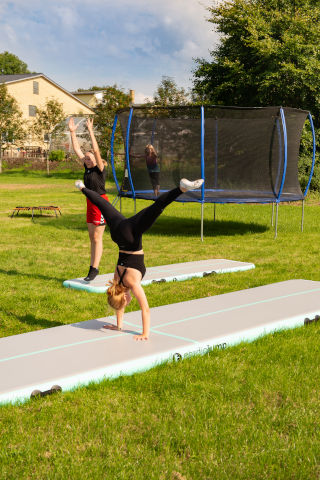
[63,258,255,293]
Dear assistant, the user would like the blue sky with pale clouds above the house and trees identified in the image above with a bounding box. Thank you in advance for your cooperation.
[0,0,218,103]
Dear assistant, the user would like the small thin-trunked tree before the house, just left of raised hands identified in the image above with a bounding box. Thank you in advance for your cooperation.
[32,99,66,174]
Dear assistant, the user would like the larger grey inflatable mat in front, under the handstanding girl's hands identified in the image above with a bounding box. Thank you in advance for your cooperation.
[0,280,320,403]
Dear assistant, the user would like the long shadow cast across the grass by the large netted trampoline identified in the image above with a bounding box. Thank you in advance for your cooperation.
[35,212,269,237]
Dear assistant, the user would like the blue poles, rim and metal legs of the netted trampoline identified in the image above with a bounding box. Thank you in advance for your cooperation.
[110,105,316,241]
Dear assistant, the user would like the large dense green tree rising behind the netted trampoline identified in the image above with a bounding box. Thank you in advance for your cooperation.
[193,0,320,120]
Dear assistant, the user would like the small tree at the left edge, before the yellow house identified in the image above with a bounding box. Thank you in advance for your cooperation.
[0,84,26,173]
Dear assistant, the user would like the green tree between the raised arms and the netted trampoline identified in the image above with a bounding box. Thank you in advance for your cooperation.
[92,85,130,159]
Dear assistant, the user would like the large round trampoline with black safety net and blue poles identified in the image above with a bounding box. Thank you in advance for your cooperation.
[111,105,315,240]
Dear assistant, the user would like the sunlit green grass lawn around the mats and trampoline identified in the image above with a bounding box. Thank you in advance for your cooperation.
[0,169,320,480]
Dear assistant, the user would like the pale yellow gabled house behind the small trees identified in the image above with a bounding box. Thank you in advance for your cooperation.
[0,73,94,151]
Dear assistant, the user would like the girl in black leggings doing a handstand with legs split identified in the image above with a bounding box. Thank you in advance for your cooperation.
[75,178,203,340]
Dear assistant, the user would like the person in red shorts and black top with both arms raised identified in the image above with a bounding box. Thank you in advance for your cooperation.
[69,117,109,282]
